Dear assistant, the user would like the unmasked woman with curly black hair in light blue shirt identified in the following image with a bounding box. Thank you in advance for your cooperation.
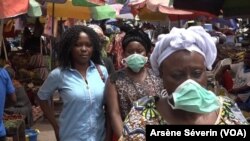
[38,25,108,141]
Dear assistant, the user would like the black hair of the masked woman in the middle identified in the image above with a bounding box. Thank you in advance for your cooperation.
[122,29,152,54]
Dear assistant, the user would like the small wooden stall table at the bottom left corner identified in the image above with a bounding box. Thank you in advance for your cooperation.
[3,115,25,141]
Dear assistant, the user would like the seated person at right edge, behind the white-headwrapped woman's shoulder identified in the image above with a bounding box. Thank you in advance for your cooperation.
[216,50,250,111]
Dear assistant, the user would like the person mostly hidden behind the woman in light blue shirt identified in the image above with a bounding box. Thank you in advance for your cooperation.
[88,24,115,74]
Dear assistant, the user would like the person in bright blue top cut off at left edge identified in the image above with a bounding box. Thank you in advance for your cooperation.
[0,66,16,141]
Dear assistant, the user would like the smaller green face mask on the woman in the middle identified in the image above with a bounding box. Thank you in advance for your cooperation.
[123,53,148,72]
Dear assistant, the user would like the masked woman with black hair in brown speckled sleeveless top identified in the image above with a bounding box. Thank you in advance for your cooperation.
[105,29,163,138]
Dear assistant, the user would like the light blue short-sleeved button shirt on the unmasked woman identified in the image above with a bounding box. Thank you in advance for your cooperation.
[38,62,108,141]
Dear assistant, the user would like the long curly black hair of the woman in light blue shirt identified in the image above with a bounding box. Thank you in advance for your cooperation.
[57,25,102,68]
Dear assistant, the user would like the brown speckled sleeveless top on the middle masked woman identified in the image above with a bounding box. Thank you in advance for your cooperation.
[110,68,163,120]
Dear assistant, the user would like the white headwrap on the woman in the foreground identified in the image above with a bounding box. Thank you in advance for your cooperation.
[150,26,217,75]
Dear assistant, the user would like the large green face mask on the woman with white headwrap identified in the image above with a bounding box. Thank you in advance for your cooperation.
[168,79,220,114]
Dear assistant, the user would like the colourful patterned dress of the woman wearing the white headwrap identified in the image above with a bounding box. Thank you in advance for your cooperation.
[120,96,248,141]
